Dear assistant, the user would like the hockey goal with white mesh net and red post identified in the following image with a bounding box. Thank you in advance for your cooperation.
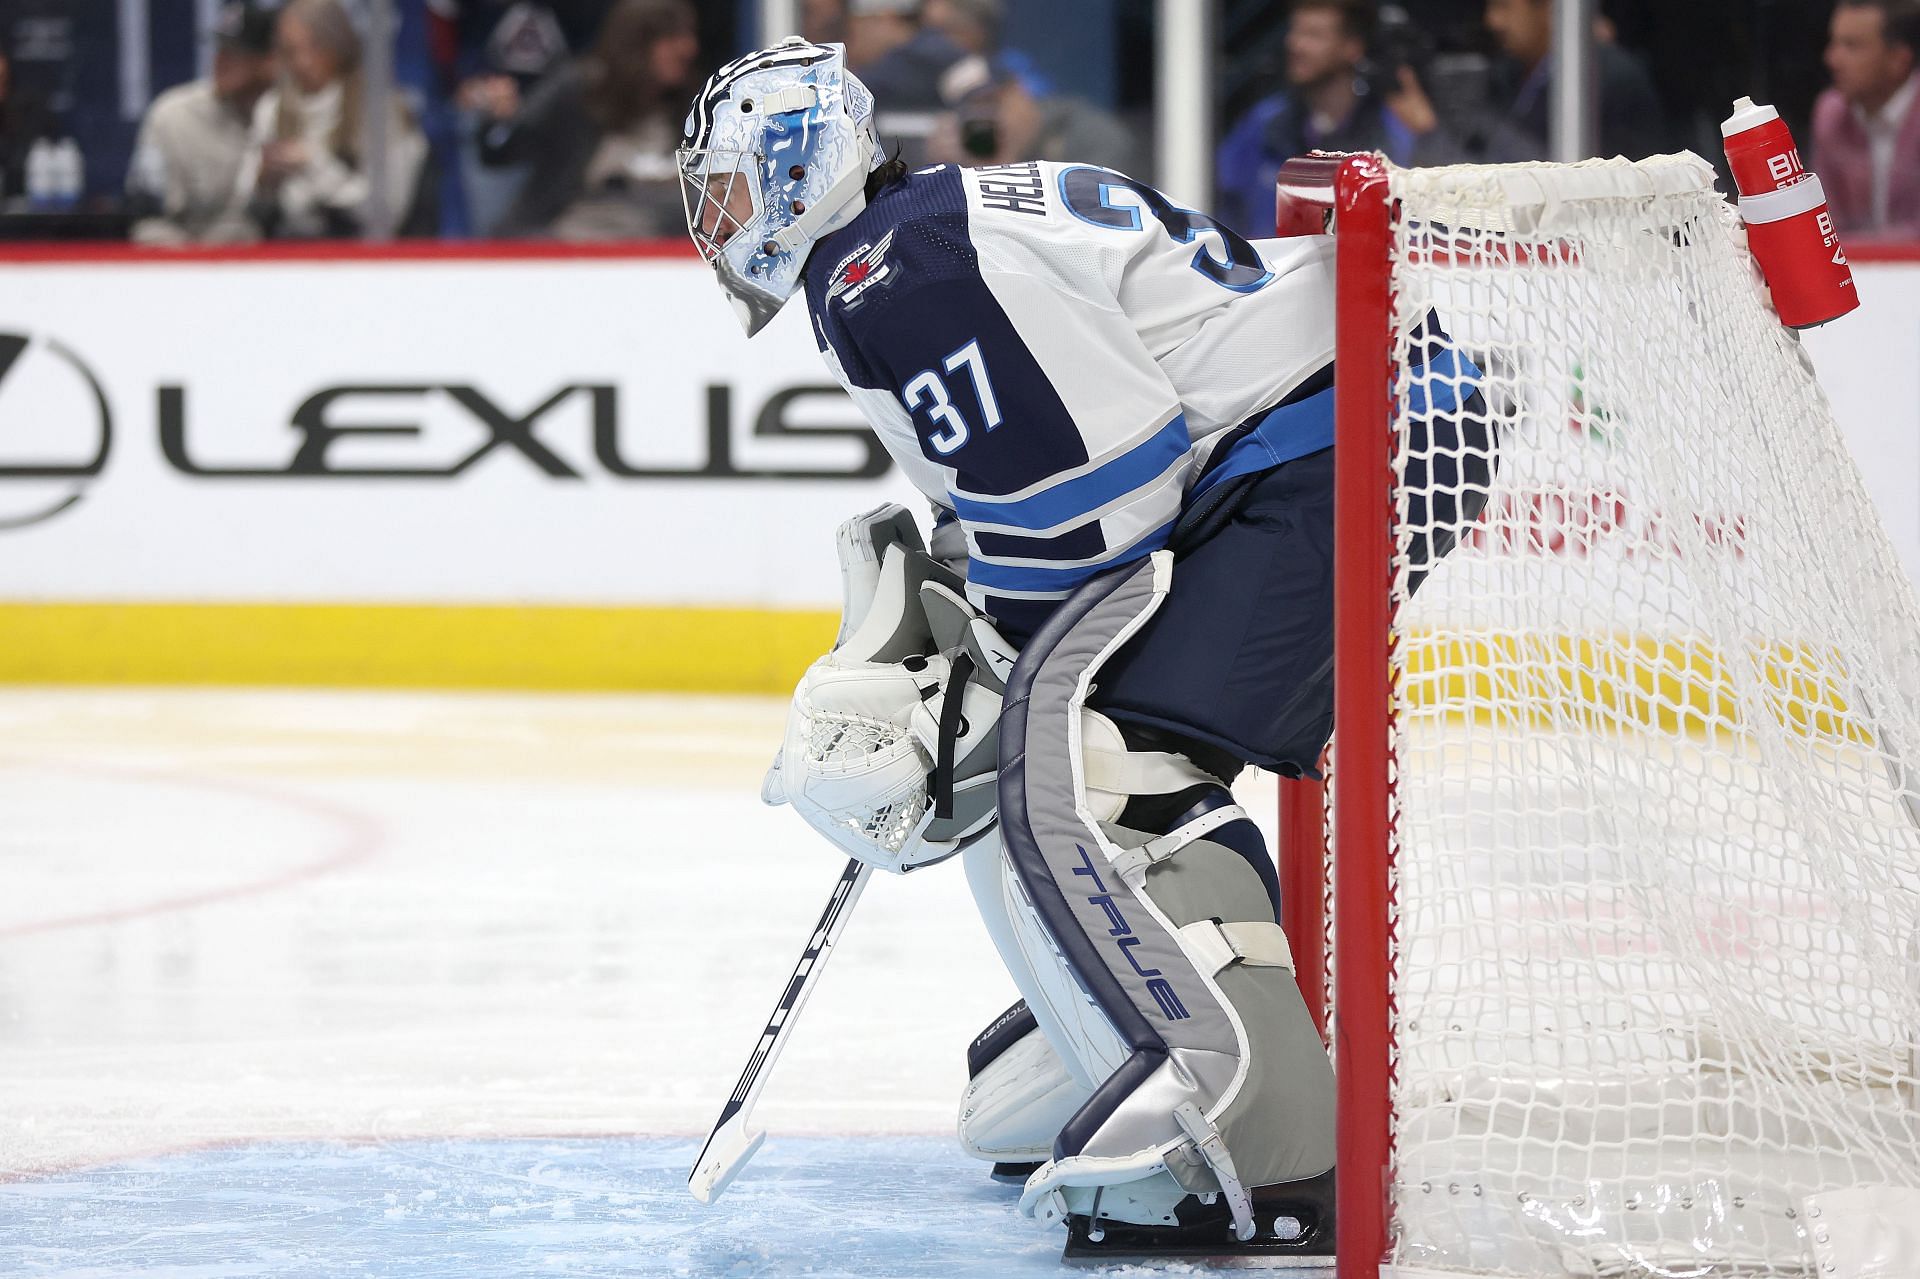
[1281,156,1920,1279]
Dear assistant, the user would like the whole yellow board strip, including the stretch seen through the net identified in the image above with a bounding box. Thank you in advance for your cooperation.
[0,603,1874,745]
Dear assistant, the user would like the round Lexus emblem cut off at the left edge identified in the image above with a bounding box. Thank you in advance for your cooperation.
[0,332,113,532]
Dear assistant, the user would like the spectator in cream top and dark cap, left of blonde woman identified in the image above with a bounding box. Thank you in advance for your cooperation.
[127,0,275,244]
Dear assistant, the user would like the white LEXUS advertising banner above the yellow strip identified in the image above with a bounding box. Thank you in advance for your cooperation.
[0,257,924,609]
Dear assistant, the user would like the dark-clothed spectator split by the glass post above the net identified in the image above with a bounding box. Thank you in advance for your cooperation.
[1484,0,1668,161]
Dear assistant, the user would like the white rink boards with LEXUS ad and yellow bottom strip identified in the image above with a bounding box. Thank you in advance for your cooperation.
[0,246,1920,691]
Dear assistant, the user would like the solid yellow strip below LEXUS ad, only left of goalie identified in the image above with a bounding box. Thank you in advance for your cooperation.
[0,603,837,693]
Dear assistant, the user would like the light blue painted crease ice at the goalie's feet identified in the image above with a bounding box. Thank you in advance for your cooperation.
[0,1137,1194,1279]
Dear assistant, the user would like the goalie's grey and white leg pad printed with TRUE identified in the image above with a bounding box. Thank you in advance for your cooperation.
[1000,553,1334,1231]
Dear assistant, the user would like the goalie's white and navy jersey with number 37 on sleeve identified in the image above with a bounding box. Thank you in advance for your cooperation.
[806,161,1334,638]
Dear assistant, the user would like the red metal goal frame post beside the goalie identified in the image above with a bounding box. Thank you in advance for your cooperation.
[1275,154,1394,1279]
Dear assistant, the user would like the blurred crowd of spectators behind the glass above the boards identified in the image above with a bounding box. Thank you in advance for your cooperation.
[0,0,1920,244]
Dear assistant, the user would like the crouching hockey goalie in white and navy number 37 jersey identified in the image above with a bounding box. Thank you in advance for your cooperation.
[680,38,1492,1254]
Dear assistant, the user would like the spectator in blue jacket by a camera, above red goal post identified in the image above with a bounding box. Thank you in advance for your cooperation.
[1213,0,1446,236]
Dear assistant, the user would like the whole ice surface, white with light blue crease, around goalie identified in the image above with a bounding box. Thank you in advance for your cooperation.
[0,689,1271,1279]
